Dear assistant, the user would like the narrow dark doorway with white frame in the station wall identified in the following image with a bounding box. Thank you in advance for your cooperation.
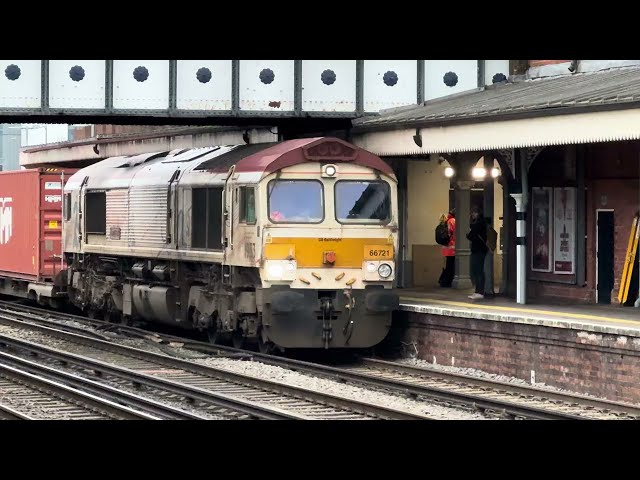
[596,210,615,304]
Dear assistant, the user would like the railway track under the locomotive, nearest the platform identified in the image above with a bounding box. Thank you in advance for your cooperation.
[0,302,640,420]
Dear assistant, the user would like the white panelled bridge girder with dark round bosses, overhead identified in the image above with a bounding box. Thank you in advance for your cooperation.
[0,60,509,124]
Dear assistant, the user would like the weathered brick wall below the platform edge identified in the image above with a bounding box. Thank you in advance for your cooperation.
[394,312,640,403]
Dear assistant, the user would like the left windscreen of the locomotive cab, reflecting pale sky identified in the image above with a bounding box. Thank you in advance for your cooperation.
[267,180,324,223]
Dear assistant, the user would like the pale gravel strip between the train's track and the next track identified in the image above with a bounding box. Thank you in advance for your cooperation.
[0,322,487,420]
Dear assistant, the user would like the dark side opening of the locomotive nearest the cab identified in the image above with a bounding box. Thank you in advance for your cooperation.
[191,188,223,250]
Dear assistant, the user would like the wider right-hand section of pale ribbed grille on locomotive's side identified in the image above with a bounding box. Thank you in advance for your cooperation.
[129,186,167,247]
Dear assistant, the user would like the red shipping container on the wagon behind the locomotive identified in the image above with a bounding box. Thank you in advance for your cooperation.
[0,168,76,282]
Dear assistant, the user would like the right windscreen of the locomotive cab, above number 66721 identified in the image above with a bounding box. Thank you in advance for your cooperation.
[335,180,391,224]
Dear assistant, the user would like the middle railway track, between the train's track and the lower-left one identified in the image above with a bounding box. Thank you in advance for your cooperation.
[0,312,429,420]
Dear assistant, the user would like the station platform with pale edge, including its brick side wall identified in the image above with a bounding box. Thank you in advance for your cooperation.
[394,289,640,403]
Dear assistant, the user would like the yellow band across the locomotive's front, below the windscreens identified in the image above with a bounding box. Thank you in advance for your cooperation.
[264,237,393,268]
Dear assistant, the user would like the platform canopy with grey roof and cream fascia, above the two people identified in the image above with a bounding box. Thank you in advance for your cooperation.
[352,67,640,156]
